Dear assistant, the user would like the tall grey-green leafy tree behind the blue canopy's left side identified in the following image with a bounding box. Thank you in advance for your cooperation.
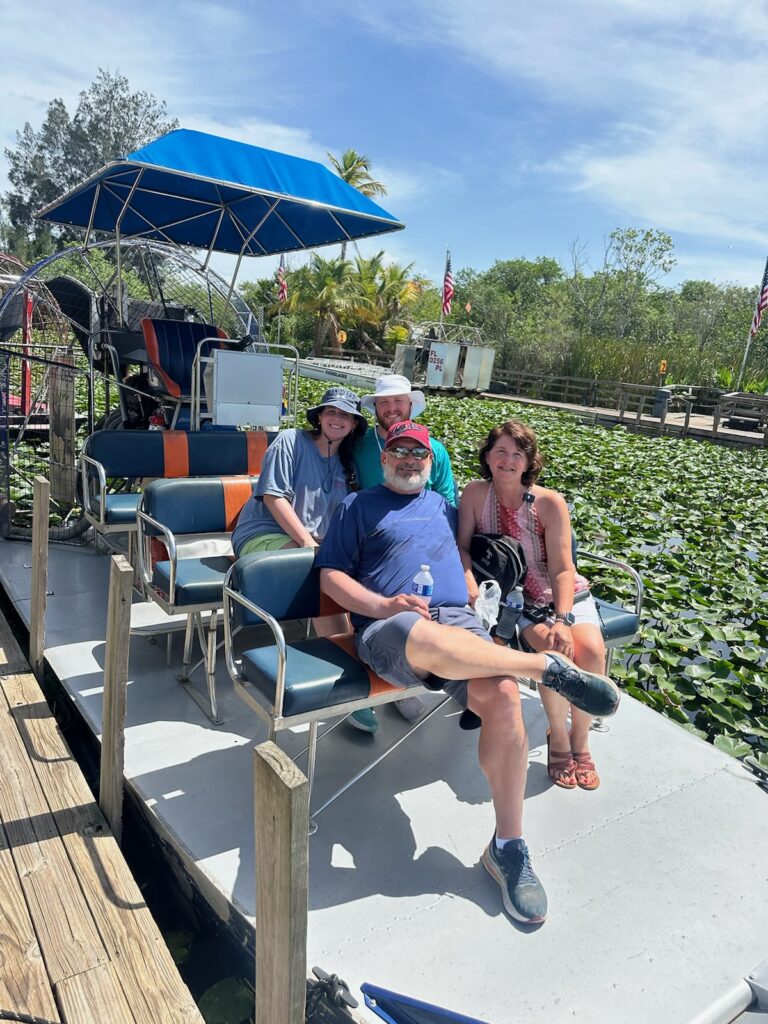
[0,69,178,258]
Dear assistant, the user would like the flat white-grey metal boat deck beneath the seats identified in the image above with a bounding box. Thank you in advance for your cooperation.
[0,541,768,1024]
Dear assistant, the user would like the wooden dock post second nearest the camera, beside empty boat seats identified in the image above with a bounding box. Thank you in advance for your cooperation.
[98,555,133,843]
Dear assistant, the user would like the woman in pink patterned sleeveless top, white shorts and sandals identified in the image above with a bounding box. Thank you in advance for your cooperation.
[459,420,605,790]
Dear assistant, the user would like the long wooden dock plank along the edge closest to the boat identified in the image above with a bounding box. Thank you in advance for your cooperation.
[0,618,202,1024]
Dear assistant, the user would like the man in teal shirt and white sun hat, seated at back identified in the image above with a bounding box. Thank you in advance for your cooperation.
[347,374,458,733]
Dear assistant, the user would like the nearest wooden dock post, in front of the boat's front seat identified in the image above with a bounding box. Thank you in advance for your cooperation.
[253,741,309,1024]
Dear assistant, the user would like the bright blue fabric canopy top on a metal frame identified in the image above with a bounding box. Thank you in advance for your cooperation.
[37,128,404,256]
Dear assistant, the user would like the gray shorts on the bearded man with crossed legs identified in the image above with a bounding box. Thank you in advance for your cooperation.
[355,605,494,708]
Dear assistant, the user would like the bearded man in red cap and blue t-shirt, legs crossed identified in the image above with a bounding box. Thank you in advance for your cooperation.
[315,420,618,924]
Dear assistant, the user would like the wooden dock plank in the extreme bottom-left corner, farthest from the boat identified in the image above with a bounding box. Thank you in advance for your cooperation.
[0,825,58,1020]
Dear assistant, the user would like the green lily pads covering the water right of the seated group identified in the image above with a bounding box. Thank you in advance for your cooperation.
[294,381,768,774]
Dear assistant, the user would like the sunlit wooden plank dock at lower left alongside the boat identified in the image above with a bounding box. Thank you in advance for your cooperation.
[0,615,203,1024]
